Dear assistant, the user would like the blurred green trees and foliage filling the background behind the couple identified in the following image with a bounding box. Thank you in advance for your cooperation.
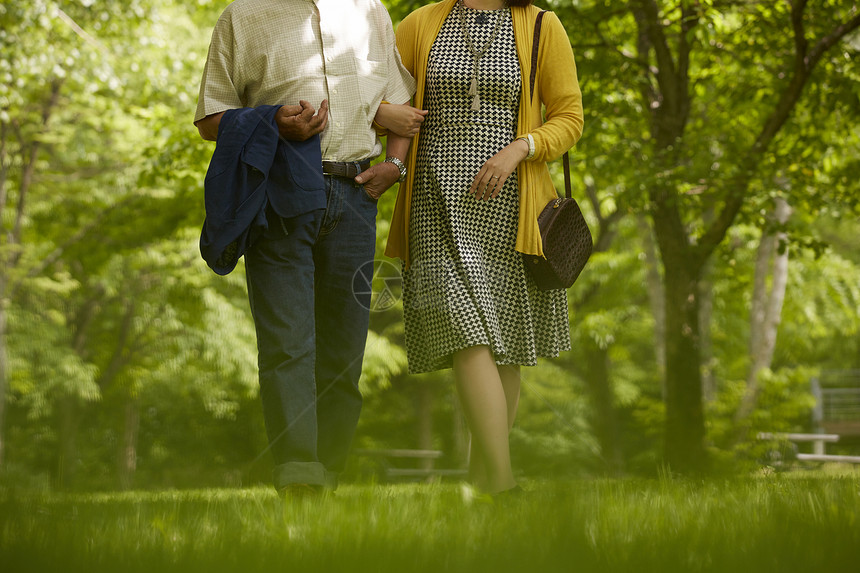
[0,0,860,490]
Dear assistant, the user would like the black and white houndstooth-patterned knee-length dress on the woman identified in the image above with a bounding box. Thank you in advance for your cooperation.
[404,7,570,373]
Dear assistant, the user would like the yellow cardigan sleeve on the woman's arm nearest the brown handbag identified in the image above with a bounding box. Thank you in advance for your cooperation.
[530,12,584,161]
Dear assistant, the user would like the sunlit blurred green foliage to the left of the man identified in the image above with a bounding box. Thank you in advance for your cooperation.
[0,0,261,487]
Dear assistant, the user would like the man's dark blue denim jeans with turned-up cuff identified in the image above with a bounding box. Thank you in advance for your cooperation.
[245,175,377,488]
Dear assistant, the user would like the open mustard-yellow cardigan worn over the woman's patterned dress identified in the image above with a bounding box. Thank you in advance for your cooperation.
[385,0,583,265]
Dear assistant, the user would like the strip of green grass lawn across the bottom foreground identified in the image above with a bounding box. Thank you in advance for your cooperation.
[0,473,860,573]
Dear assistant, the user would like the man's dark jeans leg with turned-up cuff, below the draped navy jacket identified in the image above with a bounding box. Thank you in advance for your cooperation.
[245,209,325,488]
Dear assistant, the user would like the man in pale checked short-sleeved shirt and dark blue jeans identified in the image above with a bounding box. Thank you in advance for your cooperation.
[194,0,415,495]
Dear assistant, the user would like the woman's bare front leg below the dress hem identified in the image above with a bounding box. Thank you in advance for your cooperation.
[454,346,519,493]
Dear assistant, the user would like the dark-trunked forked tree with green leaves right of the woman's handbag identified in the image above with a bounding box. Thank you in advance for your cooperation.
[559,0,860,472]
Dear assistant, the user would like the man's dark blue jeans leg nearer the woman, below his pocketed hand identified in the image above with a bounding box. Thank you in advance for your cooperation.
[314,176,376,472]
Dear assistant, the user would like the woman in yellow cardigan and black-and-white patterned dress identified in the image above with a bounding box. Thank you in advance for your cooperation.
[386,0,583,494]
